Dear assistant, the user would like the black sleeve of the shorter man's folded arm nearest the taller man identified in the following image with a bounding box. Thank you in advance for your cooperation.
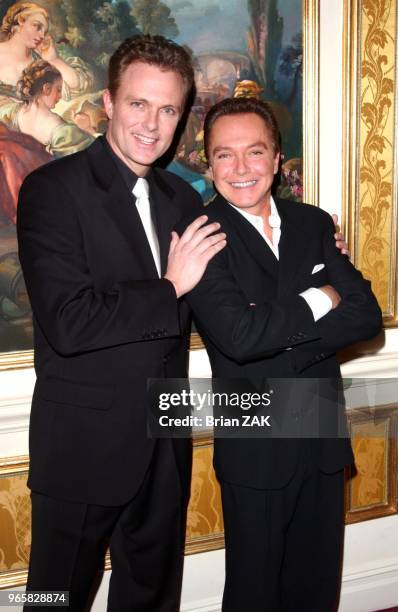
[186,239,319,363]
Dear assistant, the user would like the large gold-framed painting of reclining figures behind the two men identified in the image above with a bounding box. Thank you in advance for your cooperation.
[0,0,319,370]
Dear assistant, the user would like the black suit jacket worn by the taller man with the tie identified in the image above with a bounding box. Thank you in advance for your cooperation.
[18,138,202,505]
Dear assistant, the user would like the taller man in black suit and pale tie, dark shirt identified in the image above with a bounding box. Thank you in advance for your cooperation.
[18,36,225,612]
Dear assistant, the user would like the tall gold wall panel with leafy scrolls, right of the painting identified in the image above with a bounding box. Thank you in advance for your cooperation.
[343,0,398,326]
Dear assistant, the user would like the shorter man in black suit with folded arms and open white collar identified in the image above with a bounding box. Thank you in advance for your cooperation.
[187,98,381,612]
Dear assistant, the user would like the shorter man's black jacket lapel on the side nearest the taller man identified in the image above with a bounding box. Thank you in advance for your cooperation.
[210,196,278,278]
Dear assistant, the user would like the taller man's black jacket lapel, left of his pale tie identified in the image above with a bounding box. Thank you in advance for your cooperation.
[87,139,158,278]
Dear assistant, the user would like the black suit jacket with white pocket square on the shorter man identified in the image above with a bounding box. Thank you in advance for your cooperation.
[183,196,381,488]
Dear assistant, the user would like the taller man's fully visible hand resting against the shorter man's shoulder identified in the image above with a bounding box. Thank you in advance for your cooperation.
[164,215,227,298]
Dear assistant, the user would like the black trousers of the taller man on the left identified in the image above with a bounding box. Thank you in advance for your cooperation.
[26,440,189,612]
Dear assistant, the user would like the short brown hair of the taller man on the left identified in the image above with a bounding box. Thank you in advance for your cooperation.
[108,34,194,98]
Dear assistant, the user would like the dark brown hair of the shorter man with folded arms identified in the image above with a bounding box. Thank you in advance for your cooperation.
[203,98,281,162]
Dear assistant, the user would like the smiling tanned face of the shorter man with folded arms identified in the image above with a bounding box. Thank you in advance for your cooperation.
[208,113,279,215]
